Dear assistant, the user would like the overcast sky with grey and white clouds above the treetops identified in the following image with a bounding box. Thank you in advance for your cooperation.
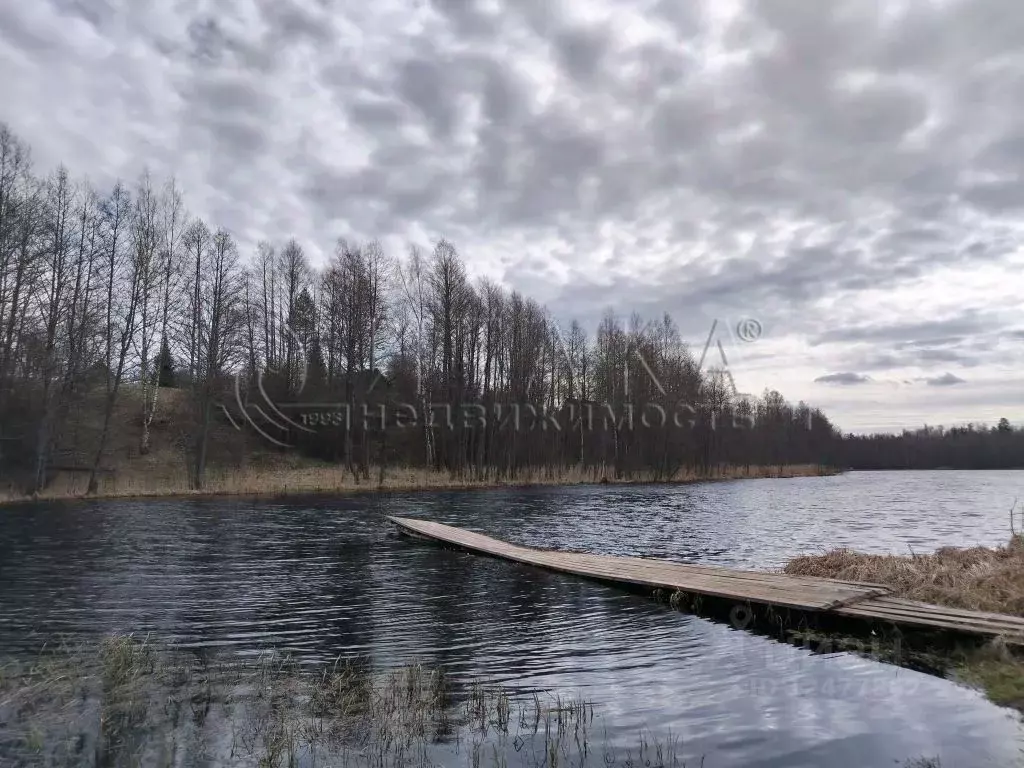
[0,0,1024,431]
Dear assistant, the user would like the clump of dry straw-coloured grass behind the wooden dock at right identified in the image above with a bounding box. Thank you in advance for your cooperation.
[784,536,1024,616]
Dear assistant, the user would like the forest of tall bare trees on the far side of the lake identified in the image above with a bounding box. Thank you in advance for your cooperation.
[0,125,1024,492]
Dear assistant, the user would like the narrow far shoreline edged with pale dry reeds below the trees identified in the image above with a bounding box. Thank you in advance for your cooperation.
[0,464,843,508]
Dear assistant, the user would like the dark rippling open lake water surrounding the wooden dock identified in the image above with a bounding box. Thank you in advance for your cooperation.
[0,472,1024,768]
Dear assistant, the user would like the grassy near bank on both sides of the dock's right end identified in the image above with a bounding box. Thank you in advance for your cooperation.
[784,535,1024,712]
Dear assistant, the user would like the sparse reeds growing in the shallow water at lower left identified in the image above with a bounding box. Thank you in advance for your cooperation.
[0,636,940,768]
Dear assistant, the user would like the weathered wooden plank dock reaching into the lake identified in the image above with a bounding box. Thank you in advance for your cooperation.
[388,517,1024,645]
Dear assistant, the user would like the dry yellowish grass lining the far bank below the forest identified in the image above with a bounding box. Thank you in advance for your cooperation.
[0,460,829,503]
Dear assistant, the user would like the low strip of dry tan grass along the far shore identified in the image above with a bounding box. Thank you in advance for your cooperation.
[0,459,840,505]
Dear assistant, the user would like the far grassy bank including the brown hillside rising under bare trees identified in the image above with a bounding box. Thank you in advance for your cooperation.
[0,386,834,504]
